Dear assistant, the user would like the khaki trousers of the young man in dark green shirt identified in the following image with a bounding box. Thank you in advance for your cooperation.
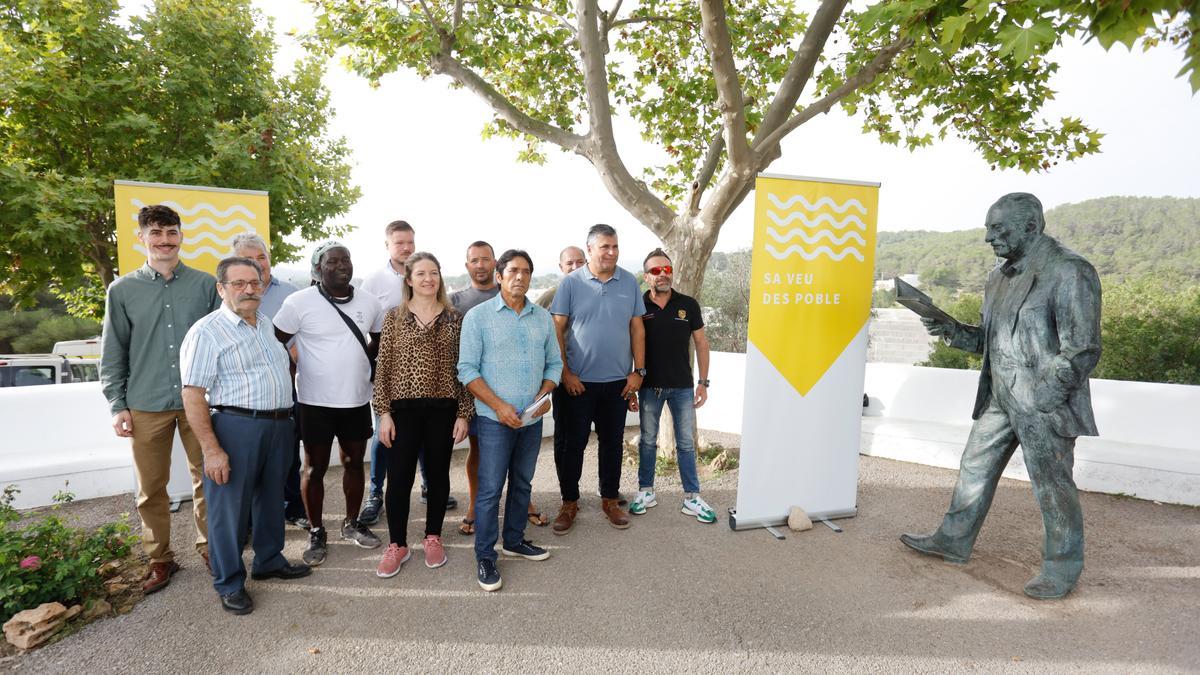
[130,410,209,562]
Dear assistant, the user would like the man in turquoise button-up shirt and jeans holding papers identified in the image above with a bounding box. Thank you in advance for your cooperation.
[458,249,563,591]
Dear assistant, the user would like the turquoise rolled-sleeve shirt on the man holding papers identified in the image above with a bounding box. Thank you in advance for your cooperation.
[458,295,563,425]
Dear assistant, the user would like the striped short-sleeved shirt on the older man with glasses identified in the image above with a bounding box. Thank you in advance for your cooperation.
[179,305,292,411]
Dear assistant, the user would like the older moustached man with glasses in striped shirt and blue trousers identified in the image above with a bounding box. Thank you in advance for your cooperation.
[180,257,312,614]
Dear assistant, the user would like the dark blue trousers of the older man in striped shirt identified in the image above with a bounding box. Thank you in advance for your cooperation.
[204,412,295,596]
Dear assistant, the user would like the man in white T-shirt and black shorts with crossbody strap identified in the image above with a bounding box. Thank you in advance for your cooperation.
[275,241,384,566]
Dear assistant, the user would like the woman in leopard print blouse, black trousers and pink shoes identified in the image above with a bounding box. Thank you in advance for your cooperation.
[372,252,474,578]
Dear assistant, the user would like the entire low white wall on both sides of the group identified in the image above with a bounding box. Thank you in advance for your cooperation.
[0,353,1200,508]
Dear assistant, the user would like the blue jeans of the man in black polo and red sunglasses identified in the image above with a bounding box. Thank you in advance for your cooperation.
[637,387,700,492]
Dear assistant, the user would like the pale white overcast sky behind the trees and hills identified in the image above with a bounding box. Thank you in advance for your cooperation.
[246,0,1200,275]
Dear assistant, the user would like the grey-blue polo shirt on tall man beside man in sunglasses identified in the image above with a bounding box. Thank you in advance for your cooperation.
[550,267,646,382]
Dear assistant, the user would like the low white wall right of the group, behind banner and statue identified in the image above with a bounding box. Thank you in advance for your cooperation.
[697,353,1200,506]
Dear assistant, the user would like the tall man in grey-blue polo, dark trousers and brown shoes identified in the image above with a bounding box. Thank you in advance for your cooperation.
[550,225,646,534]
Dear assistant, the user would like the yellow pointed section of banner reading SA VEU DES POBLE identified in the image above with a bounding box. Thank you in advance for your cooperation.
[749,174,880,396]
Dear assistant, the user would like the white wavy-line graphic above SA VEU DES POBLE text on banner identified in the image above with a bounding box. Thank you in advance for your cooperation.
[763,193,866,262]
